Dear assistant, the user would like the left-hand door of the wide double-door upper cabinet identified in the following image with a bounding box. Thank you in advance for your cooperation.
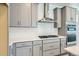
[10,3,19,26]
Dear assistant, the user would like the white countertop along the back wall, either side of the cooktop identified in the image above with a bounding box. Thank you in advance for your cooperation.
[9,33,66,45]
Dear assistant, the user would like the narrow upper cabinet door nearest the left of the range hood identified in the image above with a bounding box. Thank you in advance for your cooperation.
[32,3,38,27]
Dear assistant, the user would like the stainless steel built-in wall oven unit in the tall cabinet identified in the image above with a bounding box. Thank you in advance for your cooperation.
[67,24,76,46]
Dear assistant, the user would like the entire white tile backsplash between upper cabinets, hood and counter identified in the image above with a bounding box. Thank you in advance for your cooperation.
[9,23,58,36]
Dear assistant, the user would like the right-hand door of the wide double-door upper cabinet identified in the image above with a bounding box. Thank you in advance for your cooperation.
[20,3,31,27]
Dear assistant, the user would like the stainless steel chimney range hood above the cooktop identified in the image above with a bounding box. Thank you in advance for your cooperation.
[38,3,54,22]
